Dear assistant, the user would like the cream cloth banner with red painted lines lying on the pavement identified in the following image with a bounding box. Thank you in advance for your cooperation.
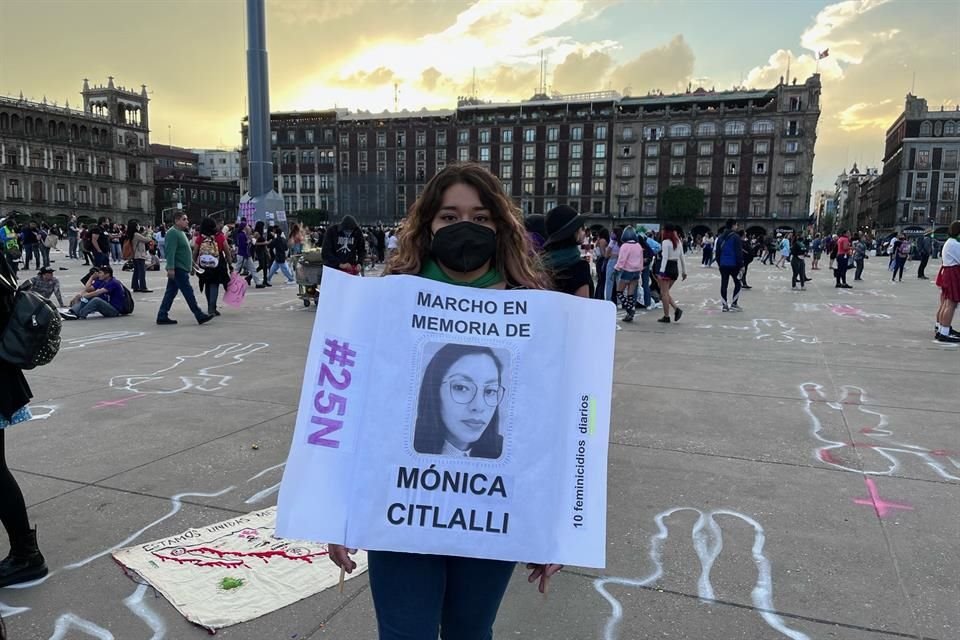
[113,507,366,629]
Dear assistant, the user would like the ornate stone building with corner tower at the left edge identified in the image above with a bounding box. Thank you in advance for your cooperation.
[0,77,154,223]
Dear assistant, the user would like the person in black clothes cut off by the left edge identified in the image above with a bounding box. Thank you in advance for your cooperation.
[0,252,47,587]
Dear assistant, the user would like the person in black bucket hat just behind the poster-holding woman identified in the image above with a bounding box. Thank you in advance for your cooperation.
[543,204,593,298]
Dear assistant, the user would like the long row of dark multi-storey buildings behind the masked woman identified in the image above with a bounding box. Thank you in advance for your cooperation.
[241,75,820,230]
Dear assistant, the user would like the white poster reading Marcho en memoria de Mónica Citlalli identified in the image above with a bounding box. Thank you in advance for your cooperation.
[277,268,616,567]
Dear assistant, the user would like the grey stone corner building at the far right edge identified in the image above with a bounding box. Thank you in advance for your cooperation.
[878,94,960,232]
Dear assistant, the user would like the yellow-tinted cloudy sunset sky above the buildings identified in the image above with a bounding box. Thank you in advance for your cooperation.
[0,0,960,195]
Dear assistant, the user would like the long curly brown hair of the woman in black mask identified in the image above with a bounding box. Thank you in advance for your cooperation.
[384,163,549,289]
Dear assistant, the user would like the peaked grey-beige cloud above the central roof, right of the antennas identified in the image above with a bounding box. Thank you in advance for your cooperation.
[608,35,694,95]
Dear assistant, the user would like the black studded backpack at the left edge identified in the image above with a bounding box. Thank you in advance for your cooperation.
[0,289,63,369]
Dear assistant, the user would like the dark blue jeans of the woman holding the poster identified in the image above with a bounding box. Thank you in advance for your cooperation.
[367,551,515,640]
